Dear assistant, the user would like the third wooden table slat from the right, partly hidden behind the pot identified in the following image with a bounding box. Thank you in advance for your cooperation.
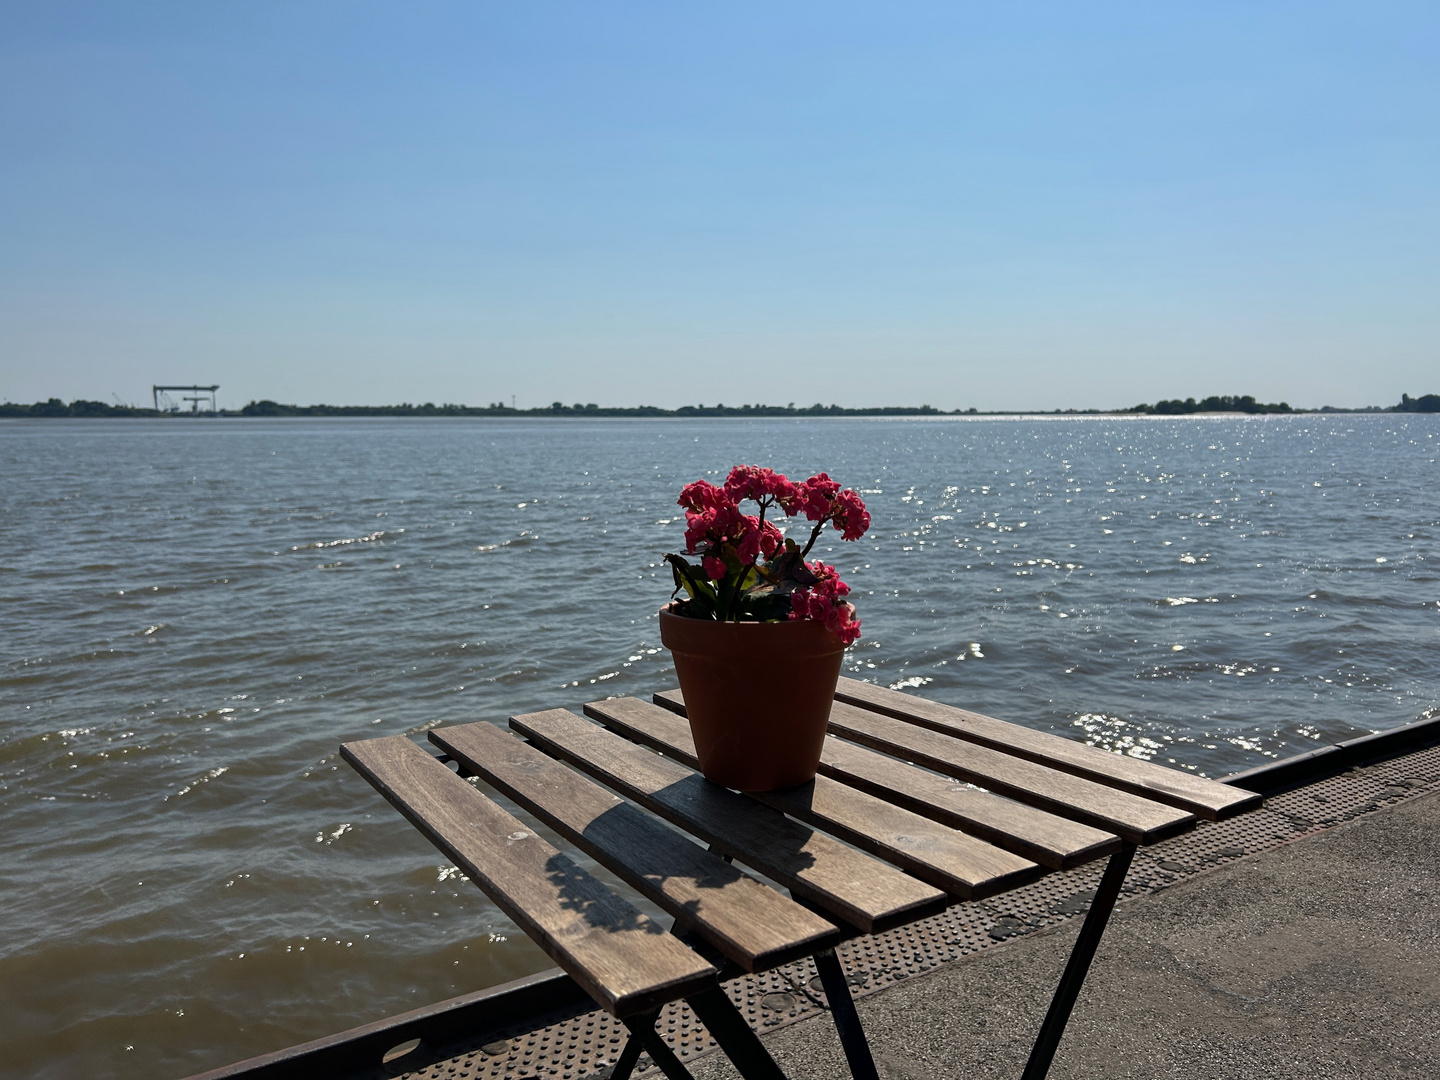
[656,690,1120,870]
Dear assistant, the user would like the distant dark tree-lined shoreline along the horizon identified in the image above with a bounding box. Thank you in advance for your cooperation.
[0,393,1440,419]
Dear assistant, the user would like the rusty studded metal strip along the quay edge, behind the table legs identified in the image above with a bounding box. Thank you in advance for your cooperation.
[380,747,1440,1080]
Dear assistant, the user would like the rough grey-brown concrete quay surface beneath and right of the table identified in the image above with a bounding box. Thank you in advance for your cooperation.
[690,793,1440,1080]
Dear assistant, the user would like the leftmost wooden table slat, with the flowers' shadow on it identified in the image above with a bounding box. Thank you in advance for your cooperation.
[340,736,716,1017]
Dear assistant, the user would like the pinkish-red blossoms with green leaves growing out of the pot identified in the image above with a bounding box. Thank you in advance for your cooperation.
[665,465,870,645]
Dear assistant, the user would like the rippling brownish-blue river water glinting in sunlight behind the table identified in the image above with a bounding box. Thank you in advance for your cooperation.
[0,415,1440,1077]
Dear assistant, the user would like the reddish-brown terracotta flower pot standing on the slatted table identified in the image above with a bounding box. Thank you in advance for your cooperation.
[660,608,845,791]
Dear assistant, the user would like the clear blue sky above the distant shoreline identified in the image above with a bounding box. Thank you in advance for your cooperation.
[0,0,1440,409]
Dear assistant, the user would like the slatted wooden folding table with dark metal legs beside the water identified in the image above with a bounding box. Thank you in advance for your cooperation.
[340,678,1261,1080]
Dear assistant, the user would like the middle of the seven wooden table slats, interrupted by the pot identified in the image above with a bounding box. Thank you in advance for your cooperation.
[585,697,1040,900]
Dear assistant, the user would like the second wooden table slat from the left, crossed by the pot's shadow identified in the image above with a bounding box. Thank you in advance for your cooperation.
[429,723,840,971]
